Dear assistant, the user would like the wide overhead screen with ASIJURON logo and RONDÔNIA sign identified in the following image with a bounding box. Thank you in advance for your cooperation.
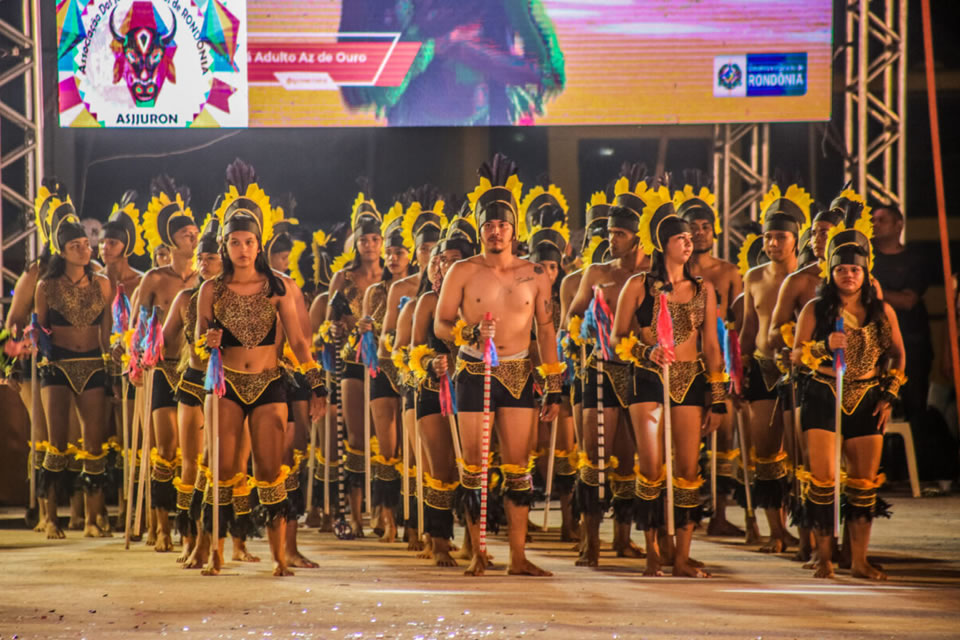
[57,0,833,127]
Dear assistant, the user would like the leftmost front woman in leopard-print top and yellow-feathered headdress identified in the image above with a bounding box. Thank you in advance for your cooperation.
[36,191,112,538]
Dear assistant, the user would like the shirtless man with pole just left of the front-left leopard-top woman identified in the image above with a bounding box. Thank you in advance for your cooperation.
[130,176,200,552]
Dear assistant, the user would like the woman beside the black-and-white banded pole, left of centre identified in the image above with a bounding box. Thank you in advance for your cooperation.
[327,192,383,538]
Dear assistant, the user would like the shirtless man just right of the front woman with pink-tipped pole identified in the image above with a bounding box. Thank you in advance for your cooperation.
[674,185,743,536]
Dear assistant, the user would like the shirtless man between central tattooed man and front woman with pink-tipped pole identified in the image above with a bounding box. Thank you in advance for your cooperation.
[568,178,650,567]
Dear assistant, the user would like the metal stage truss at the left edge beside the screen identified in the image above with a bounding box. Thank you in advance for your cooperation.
[0,0,43,315]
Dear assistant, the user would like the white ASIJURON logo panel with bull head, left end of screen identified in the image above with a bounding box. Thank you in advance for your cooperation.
[57,0,248,128]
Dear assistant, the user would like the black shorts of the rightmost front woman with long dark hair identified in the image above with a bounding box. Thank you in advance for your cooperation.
[800,377,883,439]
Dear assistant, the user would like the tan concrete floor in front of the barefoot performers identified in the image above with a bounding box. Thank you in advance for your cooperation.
[0,495,960,640]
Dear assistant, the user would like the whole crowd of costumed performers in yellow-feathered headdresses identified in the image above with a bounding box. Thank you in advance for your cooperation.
[3,154,905,579]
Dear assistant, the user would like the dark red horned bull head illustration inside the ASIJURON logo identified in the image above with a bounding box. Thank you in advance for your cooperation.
[110,0,177,107]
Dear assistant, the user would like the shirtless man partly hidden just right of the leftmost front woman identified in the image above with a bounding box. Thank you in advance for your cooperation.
[100,191,145,522]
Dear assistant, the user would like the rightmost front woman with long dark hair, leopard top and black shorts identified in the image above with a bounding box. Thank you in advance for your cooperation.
[793,211,906,580]
